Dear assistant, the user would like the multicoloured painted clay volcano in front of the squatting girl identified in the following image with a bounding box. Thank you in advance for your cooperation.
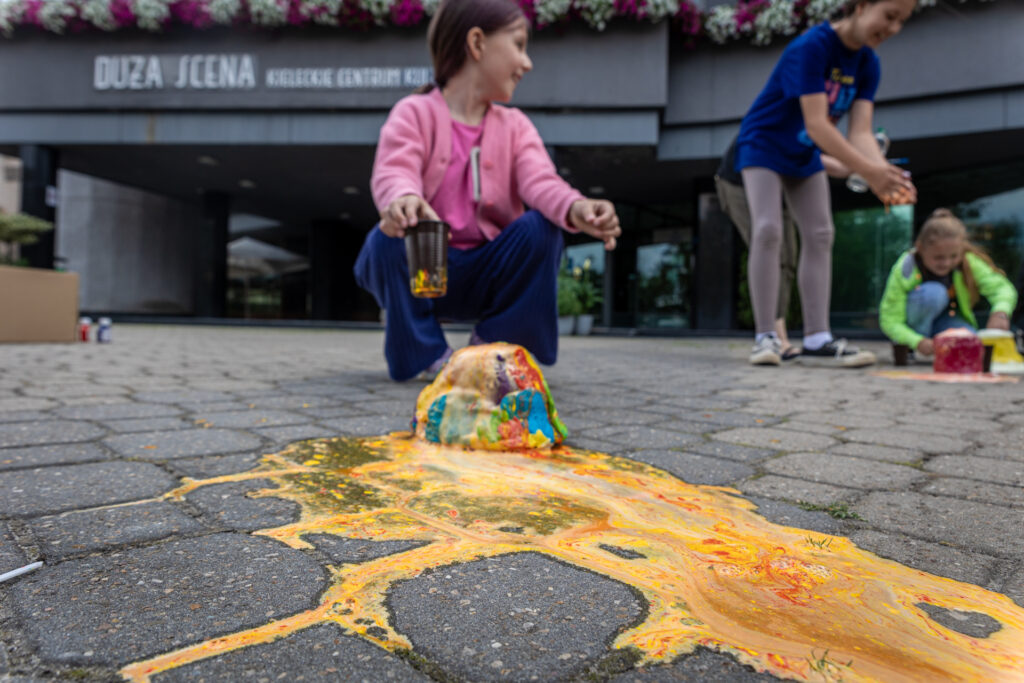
[413,343,568,451]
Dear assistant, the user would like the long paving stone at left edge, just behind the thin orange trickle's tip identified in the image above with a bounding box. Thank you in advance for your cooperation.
[0,462,175,517]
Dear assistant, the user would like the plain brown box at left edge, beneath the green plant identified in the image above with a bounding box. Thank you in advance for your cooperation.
[0,265,78,342]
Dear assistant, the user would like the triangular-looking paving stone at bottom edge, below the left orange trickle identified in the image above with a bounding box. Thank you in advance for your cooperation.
[153,624,430,683]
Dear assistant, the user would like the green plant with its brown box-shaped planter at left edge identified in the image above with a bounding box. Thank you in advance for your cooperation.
[0,213,78,342]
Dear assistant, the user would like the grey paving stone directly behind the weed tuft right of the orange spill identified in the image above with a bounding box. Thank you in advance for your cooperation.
[764,453,928,490]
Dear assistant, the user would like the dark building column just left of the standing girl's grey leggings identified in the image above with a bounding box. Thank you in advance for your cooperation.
[694,193,736,330]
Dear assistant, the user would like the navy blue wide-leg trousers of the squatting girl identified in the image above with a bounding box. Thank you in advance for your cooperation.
[354,211,562,382]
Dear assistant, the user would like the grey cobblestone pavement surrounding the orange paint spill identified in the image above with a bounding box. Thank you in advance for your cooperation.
[0,325,1024,681]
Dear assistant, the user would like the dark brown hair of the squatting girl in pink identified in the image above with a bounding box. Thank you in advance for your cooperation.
[417,0,525,92]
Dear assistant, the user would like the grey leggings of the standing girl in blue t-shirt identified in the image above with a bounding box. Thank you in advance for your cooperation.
[742,167,836,335]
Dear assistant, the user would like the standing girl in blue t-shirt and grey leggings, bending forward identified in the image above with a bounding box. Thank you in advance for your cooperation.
[736,0,916,368]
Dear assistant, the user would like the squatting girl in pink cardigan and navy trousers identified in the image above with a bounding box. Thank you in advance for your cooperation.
[355,0,622,381]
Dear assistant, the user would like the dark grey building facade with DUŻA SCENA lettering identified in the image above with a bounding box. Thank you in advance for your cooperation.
[0,0,1024,333]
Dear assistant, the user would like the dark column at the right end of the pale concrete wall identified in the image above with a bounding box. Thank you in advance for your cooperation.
[195,193,231,317]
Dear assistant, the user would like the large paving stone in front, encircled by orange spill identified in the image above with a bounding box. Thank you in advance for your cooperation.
[388,553,644,681]
